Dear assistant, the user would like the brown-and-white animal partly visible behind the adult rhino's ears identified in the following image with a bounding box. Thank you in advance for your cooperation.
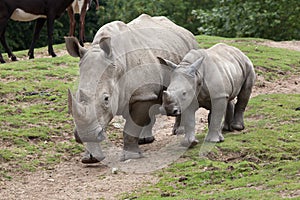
[68,0,99,46]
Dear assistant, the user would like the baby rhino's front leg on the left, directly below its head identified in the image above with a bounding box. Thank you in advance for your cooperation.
[181,110,199,147]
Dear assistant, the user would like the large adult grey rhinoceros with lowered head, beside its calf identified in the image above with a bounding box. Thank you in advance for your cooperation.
[66,14,198,164]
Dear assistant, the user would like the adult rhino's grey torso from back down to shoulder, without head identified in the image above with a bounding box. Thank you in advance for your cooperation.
[93,14,198,102]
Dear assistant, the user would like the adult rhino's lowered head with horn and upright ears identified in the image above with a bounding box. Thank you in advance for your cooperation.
[65,37,120,161]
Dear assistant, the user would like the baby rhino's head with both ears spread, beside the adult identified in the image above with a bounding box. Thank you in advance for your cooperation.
[158,57,203,116]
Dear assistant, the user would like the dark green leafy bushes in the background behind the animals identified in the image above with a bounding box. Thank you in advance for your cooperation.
[0,0,300,52]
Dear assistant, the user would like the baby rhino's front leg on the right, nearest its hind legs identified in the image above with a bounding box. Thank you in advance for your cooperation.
[205,98,227,142]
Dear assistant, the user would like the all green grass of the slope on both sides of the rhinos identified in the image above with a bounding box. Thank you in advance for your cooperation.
[0,36,300,199]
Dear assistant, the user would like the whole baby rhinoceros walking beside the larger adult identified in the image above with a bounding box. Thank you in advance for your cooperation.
[158,43,255,146]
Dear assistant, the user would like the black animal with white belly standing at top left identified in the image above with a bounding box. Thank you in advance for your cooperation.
[0,0,74,63]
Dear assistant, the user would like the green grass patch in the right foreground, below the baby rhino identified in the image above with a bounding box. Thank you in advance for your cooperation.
[124,94,300,199]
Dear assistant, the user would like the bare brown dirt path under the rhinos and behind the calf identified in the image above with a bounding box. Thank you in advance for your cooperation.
[0,41,300,199]
